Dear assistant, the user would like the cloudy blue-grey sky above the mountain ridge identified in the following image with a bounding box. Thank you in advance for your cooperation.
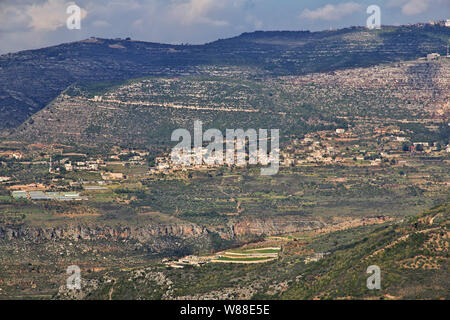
[0,0,450,54]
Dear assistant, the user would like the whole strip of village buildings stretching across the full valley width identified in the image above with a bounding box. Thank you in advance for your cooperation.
[0,120,450,200]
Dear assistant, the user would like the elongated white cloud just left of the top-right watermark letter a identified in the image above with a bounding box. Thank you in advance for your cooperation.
[300,2,362,21]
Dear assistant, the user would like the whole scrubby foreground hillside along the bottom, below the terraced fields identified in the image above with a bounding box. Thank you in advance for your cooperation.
[55,203,450,299]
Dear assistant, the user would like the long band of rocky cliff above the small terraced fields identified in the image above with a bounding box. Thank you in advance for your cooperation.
[0,218,323,242]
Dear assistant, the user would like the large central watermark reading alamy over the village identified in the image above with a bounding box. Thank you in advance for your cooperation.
[171,120,280,175]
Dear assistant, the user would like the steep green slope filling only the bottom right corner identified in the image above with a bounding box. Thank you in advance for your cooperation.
[281,203,450,299]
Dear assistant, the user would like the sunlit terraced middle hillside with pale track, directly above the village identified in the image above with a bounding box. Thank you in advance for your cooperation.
[10,58,450,148]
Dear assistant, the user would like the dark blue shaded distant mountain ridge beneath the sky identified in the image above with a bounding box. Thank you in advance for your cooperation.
[0,25,450,130]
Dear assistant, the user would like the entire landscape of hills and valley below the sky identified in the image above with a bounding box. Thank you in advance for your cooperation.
[0,24,450,300]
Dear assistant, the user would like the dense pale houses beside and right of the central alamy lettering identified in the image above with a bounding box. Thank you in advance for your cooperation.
[142,121,450,174]
